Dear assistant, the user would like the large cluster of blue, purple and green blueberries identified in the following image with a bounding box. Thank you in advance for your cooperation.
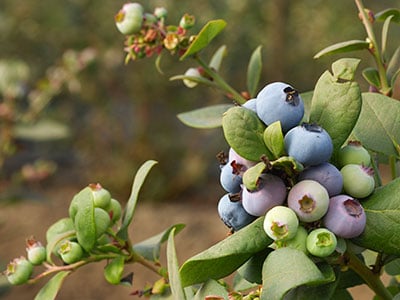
[218,82,375,257]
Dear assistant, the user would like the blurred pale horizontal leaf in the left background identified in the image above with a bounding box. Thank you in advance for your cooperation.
[13,120,70,142]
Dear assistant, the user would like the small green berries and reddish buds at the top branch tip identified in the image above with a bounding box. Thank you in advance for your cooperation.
[115,3,195,62]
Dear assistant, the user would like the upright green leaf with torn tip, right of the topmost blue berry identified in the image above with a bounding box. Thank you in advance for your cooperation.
[310,59,361,157]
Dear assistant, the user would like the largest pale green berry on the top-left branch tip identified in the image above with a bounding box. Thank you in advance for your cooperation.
[114,3,144,35]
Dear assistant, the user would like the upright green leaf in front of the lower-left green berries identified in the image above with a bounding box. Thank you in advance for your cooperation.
[71,187,97,252]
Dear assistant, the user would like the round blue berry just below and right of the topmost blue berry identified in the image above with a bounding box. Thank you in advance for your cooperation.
[284,123,333,166]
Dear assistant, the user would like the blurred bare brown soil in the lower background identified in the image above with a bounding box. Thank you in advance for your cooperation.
[0,187,373,300]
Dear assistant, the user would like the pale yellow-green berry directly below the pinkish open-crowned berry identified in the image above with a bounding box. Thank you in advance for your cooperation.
[264,206,299,241]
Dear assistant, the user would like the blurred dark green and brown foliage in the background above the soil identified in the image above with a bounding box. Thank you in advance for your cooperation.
[0,0,399,201]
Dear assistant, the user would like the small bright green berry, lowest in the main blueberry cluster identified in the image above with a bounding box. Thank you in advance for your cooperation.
[306,228,337,257]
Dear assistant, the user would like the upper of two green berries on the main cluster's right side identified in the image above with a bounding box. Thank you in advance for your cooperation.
[338,141,371,168]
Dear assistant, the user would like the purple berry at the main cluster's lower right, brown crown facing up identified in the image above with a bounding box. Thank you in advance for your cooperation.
[323,195,367,239]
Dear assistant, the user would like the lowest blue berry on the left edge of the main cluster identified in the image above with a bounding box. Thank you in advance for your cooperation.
[218,194,256,231]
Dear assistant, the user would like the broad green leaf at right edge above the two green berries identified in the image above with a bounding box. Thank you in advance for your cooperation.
[353,93,400,157]
